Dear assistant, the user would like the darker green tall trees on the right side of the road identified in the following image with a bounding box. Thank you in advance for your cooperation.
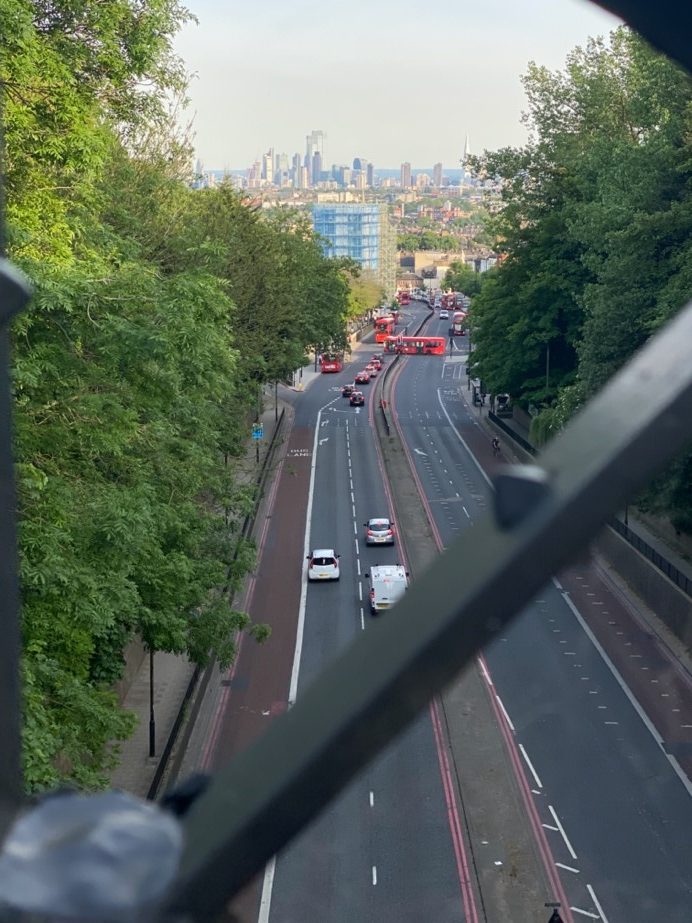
[472,27,692,528]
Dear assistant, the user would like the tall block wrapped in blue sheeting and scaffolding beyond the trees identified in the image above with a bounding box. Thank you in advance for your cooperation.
[312,203,396,297]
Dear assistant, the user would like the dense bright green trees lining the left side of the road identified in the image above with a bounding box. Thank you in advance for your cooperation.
[0,0,349,790]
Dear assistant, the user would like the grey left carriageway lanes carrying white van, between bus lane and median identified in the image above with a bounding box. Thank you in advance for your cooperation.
[260,304,473,923]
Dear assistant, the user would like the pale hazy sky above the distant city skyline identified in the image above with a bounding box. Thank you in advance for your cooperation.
[175,0,619,169]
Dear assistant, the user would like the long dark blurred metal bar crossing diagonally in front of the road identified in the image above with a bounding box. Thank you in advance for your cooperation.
[166,304,692,920]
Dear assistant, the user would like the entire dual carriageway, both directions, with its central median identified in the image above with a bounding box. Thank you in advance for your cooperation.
[176,305,692,923]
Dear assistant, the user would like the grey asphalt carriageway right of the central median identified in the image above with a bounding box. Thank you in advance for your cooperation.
[393,308,692,923]
